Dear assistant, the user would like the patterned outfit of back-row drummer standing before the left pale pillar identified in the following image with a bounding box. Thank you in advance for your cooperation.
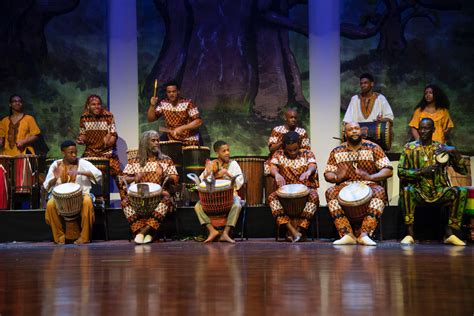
[79,109,126,198]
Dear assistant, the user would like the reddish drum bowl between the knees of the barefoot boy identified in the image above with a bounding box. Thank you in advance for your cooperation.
[198,179,234,216]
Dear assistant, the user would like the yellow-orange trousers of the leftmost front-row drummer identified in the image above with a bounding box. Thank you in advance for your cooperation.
[45,195,95,243]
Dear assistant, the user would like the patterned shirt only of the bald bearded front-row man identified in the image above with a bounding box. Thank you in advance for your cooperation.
[324,139,392,184]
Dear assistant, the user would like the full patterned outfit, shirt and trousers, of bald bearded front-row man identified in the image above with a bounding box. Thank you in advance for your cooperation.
[324,139,392,237]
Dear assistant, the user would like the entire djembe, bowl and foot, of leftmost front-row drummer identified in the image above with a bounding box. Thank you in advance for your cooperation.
[52,183,83,240]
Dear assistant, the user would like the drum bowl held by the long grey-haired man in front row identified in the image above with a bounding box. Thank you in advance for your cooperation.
[128,182,163,217]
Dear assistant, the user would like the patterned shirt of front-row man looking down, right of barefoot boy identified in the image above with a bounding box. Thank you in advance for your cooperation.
[270,149,319,189]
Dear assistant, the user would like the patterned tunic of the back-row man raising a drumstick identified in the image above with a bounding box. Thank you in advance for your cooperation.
[155,98,200,146]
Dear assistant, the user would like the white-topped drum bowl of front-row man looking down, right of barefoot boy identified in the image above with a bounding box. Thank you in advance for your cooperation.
[276,184,309,218]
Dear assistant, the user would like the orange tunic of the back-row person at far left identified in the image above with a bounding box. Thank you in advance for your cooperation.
[0,114,41,156]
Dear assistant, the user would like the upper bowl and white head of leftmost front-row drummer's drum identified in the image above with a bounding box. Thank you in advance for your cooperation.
[52,183,83,221]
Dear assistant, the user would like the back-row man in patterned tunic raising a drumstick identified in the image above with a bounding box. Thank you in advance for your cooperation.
[147,81,202,146]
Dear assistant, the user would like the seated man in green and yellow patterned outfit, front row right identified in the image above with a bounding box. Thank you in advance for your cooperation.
[398,118,467,246]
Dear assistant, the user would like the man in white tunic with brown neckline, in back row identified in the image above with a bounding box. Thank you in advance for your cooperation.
[343,73,393,123]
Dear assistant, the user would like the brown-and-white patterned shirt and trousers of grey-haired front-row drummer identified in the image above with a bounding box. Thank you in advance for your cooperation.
[122,157,178,233]
